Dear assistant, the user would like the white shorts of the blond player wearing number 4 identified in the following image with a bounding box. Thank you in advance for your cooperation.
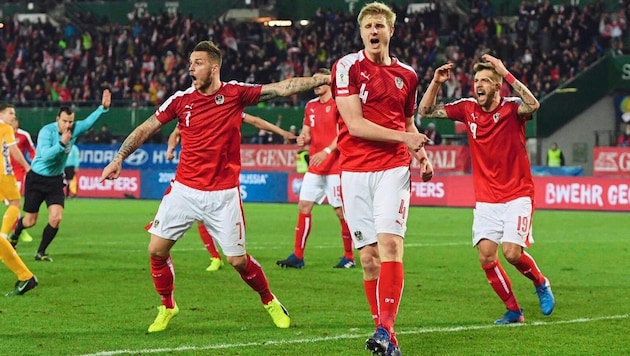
[341,167,411,249]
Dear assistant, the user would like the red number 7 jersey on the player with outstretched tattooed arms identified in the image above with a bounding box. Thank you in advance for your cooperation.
[155,81,262,191]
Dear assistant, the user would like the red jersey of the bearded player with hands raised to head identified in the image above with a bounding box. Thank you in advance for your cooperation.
[444,97,534,203]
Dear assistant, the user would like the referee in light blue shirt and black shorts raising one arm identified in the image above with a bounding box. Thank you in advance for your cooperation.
[9,89,112,262]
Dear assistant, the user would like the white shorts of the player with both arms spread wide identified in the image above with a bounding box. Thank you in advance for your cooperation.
[147,181,245,256]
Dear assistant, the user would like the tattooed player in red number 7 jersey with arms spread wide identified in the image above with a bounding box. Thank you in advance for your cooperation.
[101,41,330,332]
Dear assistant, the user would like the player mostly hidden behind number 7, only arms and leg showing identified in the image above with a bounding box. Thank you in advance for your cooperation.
[166,112,296,272]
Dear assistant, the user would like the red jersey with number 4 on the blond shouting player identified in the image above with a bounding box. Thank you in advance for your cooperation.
[332,51,418,172]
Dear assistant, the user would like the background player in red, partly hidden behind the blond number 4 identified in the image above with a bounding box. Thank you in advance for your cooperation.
[276,68,355,268]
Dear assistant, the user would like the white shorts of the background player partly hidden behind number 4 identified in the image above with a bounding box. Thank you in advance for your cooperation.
[300,172,341,208]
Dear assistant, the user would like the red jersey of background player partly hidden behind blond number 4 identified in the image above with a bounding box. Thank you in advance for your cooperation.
[303,98,339,175]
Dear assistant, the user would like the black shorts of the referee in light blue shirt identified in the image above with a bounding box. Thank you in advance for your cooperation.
[24,170,66,213]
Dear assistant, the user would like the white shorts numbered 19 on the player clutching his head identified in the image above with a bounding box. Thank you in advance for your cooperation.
[472,197,534,247]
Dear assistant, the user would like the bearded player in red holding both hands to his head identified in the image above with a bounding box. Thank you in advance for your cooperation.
[420,54,555,324]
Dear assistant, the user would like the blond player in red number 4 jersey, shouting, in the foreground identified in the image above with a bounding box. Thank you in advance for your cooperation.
[332,2,433,355]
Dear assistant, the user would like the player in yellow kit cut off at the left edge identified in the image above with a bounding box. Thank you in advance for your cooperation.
[0,103,38,297]
